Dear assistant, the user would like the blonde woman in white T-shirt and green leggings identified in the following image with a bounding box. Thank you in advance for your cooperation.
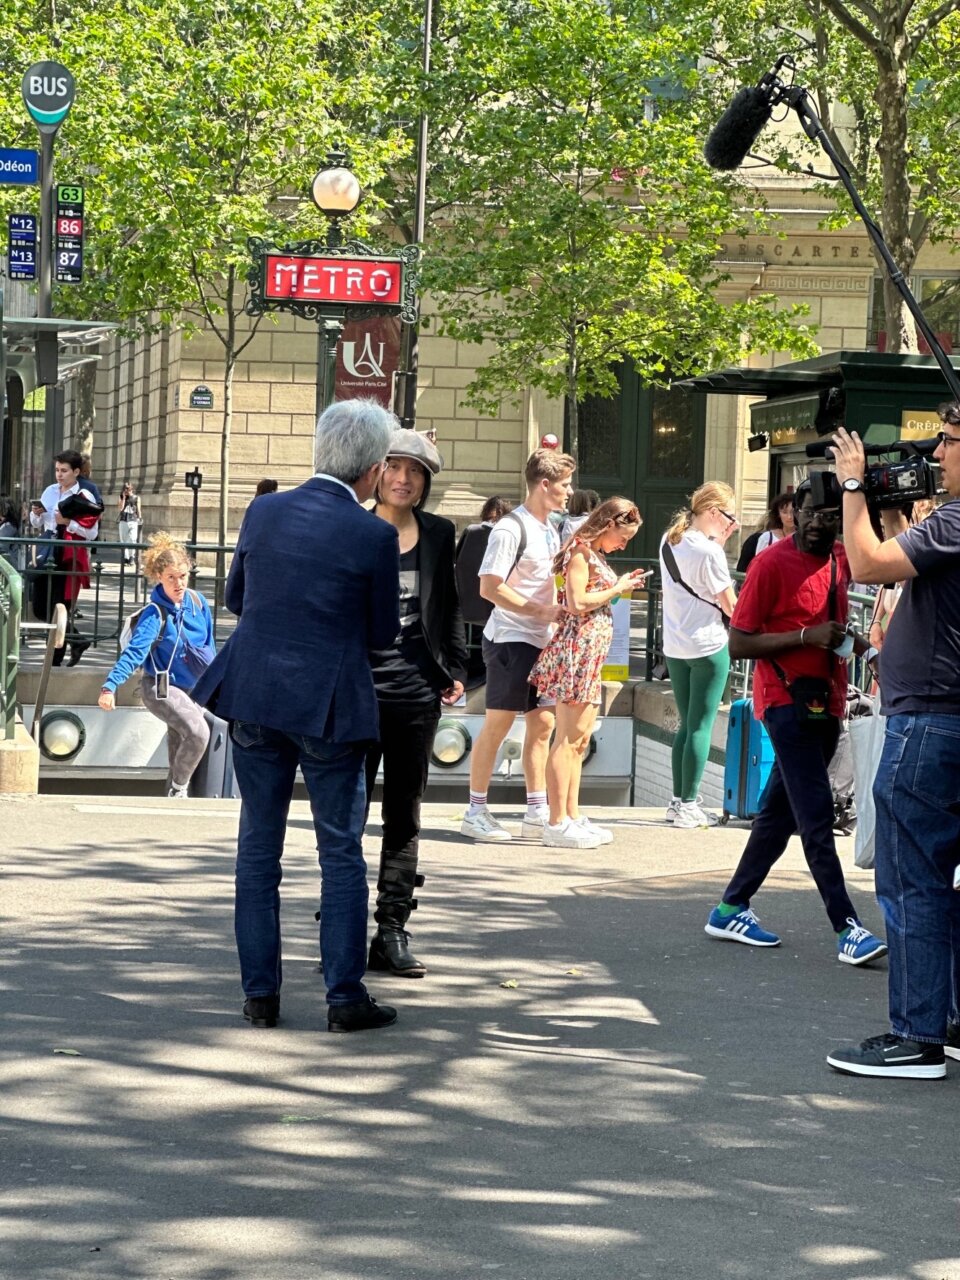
[660,481,737,827]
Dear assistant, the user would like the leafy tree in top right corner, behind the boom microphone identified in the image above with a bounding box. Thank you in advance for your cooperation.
[696,0,960,352]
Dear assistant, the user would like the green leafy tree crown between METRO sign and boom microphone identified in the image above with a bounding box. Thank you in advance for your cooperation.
[371,0,812,458]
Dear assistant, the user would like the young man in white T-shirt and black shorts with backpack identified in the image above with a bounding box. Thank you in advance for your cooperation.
[460,449,576,841]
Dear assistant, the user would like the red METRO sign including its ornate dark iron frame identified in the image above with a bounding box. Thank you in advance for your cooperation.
[247,238,420,324]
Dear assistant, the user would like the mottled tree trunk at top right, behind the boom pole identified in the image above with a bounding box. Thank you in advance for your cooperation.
[874,47,918,355]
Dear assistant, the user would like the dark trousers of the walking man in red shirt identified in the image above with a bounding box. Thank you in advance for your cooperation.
[723,705,858,933]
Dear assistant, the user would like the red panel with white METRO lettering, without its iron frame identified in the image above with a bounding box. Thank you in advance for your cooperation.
[264,253,403,307]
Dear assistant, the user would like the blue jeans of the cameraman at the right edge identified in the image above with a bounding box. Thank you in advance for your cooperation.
[873,714,960,1044]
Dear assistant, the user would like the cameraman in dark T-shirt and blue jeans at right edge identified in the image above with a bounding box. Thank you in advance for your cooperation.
[827,419,960,1079]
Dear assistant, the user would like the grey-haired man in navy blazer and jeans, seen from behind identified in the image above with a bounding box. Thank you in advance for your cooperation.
[193,401,399,1032]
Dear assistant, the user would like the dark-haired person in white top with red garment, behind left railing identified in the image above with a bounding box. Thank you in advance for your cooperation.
[29,449,104,667]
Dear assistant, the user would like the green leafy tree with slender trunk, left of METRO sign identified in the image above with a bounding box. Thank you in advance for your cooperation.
[0,0,406,541]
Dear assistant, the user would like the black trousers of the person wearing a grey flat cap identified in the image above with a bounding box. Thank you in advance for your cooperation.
[365,699,440,924]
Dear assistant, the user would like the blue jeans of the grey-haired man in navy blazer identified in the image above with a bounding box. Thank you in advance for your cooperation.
[230,721,367,1005]
